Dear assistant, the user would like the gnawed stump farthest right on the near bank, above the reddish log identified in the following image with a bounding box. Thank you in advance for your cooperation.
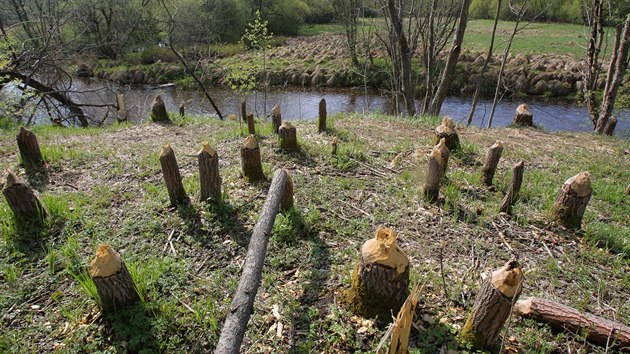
[551,172,593,229]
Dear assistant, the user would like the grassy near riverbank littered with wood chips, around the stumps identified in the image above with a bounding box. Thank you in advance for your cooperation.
[0,115,630,353]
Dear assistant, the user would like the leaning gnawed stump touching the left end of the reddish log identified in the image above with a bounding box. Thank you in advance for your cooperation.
[461,259,523,349]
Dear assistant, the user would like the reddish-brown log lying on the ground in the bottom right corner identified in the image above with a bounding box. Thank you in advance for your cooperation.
[514,297,630,350]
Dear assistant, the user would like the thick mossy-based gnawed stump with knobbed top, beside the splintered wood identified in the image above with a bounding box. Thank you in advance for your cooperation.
[347,228,410,323]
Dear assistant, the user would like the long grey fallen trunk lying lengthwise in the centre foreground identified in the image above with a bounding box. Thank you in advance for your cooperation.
[215,170,290,354]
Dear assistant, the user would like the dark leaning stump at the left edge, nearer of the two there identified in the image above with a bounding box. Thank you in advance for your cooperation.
[2,173,46,229]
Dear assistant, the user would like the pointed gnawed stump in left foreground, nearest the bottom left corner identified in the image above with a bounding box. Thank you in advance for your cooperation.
[90,244,140,314]
